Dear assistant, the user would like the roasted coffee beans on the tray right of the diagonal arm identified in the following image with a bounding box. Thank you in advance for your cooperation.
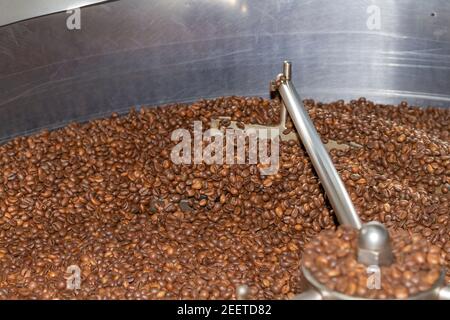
[309,98,450,282]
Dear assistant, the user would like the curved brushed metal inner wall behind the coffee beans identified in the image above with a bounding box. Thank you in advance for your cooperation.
[0,0,450,139]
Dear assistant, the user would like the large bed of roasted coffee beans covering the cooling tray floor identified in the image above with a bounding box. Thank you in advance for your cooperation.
[0,97,450,299]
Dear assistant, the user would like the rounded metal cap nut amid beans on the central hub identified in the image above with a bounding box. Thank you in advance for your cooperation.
[358,221,394,266]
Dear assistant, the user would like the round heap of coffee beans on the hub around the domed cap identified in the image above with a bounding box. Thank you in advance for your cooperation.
[303,227,445,299]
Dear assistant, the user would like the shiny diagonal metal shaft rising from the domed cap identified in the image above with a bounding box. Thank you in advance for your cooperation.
[278,62,362,229]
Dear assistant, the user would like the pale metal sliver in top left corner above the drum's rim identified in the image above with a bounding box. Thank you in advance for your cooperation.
[0,0,108,26]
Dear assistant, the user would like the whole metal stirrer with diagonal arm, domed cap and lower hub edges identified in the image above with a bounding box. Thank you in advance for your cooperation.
[271,61,450,300]
